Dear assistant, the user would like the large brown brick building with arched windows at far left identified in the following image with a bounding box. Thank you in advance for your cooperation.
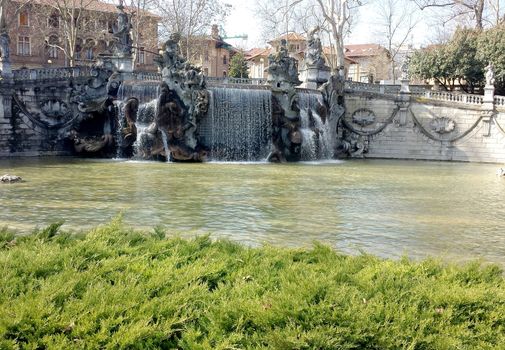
[6,0,159,71]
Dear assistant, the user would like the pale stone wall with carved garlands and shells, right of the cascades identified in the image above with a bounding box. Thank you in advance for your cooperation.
[344,92,505,163]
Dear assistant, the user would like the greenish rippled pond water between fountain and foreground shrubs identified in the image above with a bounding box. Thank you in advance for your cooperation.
[0,159,505,266]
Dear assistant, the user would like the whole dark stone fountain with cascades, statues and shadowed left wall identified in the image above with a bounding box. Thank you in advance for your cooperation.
[2,1,343,162]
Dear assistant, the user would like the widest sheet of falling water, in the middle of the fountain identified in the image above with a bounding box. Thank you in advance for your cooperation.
[199,88,272,161]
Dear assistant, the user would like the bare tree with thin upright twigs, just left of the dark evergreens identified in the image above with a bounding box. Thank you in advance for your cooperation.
[376,0,419,84]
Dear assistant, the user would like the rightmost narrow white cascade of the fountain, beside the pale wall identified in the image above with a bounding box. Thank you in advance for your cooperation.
[298,90,336,160]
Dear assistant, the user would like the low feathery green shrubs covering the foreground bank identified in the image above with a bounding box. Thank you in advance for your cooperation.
[0,220,505,349]
